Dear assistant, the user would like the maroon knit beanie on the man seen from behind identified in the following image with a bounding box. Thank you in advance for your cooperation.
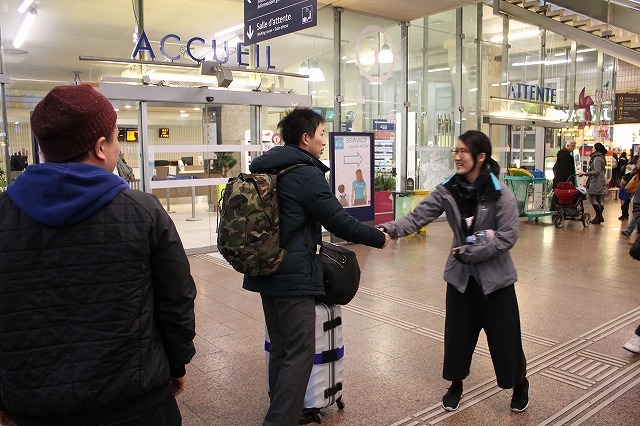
[31,84,118,163]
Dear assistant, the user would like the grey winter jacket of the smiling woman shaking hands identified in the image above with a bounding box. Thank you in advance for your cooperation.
[380,174,519,295]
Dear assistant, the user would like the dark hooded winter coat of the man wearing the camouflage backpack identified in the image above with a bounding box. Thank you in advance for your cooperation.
[244,145,385,296]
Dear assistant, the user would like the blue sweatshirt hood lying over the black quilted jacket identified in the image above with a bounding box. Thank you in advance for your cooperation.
[7,163,129,228]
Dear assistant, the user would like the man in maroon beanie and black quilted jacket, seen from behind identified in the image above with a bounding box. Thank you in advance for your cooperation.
[0,85,196,426]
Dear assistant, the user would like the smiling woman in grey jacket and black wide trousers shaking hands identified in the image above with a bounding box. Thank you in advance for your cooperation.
[378,130,529,412]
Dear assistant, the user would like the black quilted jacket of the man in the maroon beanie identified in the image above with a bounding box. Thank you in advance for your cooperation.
[0,187,196,425]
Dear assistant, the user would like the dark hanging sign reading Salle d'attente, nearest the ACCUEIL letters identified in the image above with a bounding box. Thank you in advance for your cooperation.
[244,0,318,46]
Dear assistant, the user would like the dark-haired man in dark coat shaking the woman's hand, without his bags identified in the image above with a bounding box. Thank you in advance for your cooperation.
[243,108,387,426]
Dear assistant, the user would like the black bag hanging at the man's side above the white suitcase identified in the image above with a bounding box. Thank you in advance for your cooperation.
[316,241,360,305]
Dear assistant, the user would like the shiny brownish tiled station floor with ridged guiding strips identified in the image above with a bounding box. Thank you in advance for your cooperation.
[174,201,640,426]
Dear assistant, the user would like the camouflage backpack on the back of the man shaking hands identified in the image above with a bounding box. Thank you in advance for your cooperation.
[218,164,303,276]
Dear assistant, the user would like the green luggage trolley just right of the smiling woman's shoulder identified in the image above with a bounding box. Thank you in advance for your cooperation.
[504,169,554,222]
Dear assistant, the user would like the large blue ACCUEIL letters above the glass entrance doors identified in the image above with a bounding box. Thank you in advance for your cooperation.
[131,31,276,69]
